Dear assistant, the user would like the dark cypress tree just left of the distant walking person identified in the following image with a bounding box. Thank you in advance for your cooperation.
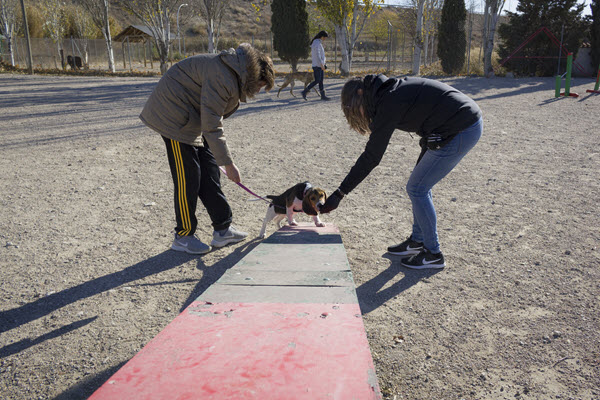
[271,0,310,71]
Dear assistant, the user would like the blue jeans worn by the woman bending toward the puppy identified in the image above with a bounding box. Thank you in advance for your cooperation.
[406,119,483,253]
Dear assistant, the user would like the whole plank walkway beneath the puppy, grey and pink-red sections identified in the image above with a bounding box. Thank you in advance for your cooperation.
[90,223,381,400]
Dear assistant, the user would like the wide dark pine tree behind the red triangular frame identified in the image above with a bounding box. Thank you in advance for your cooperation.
[498,0,587,76]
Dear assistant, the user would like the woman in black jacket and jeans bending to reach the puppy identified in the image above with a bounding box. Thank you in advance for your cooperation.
[320,74,483,269]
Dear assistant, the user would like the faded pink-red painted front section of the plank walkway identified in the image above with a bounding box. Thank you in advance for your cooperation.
[90,301,381,400]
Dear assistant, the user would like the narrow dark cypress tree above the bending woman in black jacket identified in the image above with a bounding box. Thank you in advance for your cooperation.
[437,0,467,75]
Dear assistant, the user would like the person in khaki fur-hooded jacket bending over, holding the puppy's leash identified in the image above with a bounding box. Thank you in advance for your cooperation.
[140,43,275,254]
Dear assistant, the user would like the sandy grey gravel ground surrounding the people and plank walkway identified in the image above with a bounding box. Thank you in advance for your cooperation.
[0,74,600,400]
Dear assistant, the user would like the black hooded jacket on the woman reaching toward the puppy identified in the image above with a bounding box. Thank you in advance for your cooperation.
[340,74,481,193]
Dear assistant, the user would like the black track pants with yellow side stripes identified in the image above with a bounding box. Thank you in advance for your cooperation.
[163,136,232,236]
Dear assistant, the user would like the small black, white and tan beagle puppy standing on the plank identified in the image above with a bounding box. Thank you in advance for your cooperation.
[259,182,327,239]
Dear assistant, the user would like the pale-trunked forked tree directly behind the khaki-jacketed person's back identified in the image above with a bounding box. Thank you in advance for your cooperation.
[115,0,184,74]
